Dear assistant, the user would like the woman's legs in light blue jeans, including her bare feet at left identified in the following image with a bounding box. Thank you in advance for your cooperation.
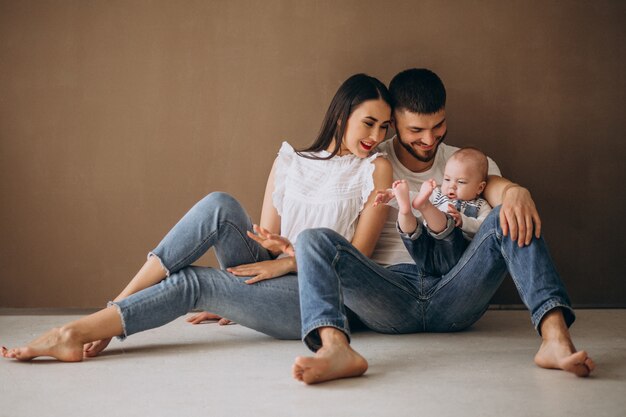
[0,193,299,361]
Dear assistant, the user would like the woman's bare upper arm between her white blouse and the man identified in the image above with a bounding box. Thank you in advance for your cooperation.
[352,158,393,257]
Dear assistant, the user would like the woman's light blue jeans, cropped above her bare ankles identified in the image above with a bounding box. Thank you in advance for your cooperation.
[112,193,300,339]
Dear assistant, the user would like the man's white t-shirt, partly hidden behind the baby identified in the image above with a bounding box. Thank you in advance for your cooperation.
[372,139,500,265]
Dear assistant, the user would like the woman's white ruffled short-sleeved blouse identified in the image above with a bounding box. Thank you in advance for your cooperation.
[272,142,383,243]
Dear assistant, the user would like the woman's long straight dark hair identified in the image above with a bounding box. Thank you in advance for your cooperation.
[296,74,391,159]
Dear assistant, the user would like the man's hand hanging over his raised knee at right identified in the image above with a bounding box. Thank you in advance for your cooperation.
[500,184,541,248]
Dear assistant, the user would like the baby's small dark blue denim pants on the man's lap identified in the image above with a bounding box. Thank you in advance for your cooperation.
[398,216,469,276]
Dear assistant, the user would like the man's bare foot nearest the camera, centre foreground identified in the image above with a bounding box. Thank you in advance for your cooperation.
[292,328,368,384]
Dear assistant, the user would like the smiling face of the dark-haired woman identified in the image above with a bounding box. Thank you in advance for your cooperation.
[331,99,391,158]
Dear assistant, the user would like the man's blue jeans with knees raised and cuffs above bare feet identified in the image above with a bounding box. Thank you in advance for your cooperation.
[296,207,574,351]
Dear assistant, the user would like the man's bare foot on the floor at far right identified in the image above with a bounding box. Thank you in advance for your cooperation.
[535,339,596,376]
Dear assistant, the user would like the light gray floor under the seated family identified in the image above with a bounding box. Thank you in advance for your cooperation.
[0,310,626,417]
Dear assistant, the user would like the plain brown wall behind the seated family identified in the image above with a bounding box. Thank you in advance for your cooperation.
[0,0,626,307]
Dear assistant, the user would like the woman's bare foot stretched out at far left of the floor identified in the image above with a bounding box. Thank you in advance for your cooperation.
[2,328,83,362]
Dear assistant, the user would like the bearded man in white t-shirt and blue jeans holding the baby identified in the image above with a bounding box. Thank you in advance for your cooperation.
[293,69,594,383]
